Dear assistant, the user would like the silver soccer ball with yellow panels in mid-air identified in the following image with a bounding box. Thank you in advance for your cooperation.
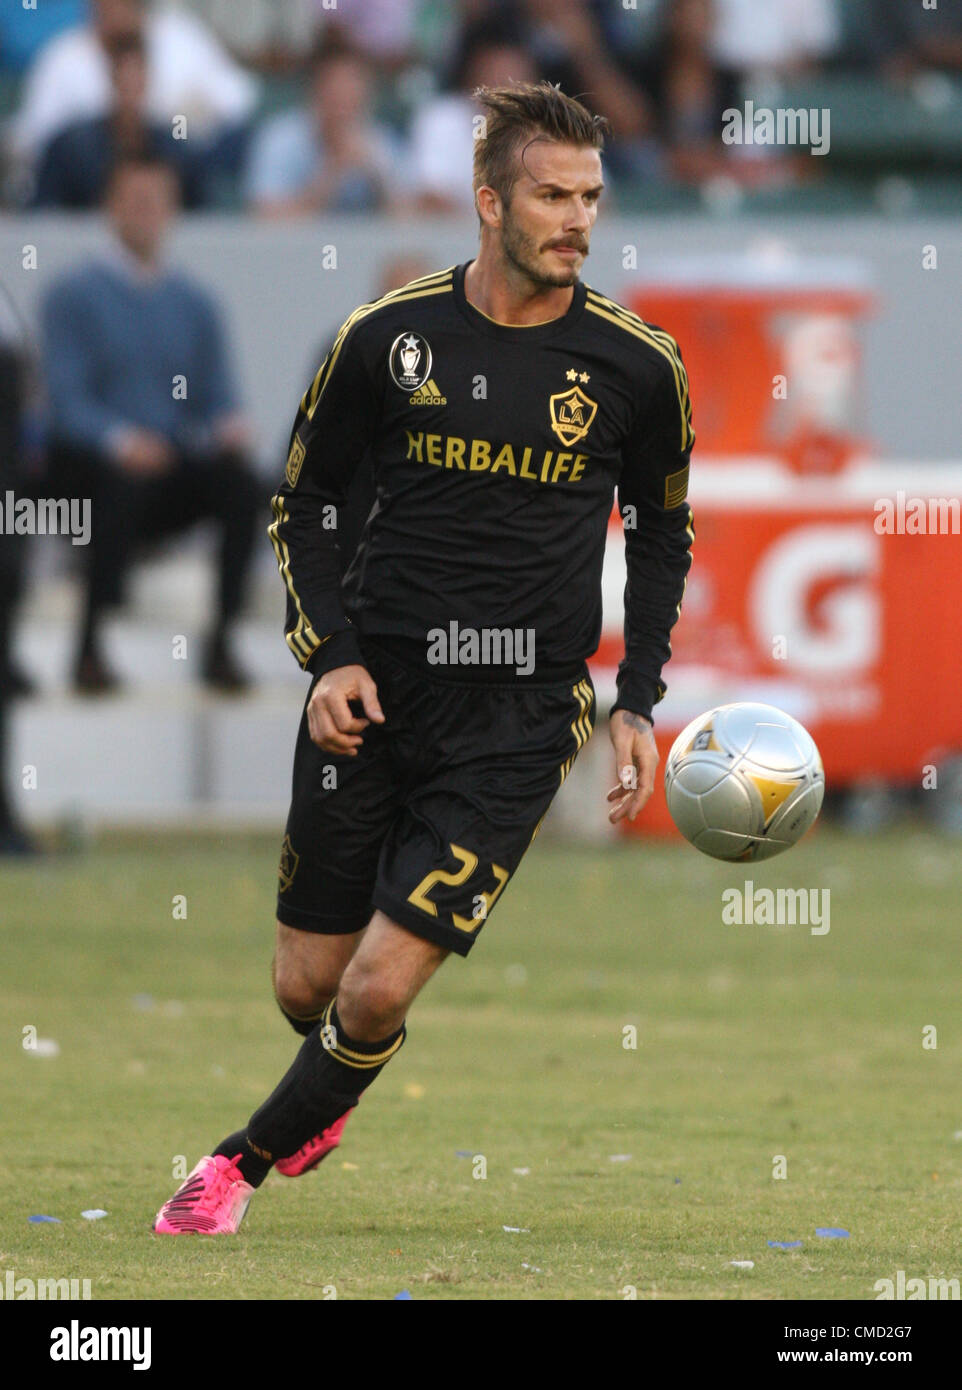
[665,705,824,860]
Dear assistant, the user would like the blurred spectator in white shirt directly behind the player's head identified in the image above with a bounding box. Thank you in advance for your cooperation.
[411,19,541,213]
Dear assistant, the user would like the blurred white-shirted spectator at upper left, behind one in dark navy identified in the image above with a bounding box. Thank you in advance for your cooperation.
[13,0,259,179]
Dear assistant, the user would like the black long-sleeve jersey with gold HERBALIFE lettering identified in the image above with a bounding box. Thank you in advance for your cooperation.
[270,263,695,716]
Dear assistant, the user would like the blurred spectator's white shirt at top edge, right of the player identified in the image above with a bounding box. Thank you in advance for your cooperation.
[712,0,841,79]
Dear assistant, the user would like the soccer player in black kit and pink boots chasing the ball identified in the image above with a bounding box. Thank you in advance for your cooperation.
[154,82,694,1234]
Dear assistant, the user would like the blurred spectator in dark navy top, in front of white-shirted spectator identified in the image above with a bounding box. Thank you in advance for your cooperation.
[33,33,202,209]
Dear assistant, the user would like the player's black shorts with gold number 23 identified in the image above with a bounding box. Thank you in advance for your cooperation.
[277,639,595,955]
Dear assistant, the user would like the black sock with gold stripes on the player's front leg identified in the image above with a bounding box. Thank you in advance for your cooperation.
[244,999,406,1170]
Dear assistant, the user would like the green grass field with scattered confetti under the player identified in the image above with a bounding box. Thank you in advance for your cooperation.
[0,826,962,1300]
